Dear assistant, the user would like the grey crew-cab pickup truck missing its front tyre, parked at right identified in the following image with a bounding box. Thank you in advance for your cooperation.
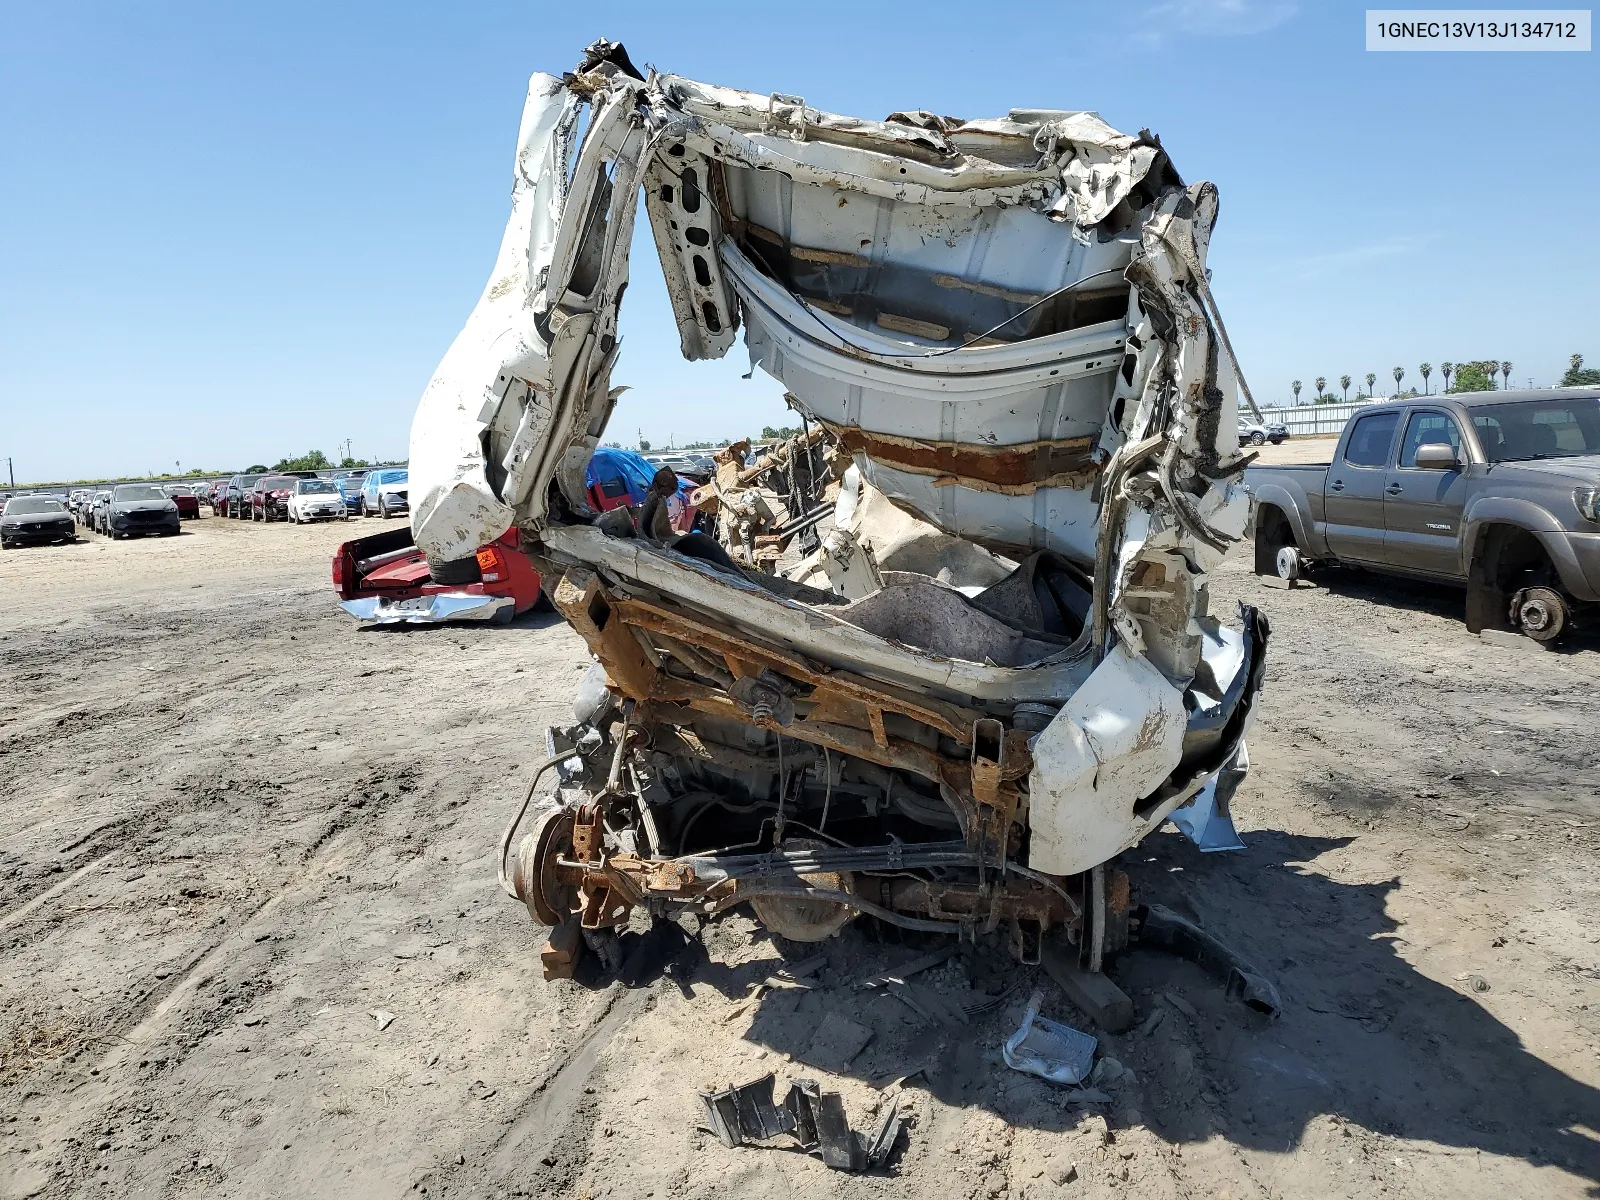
[1245,389,1600,642]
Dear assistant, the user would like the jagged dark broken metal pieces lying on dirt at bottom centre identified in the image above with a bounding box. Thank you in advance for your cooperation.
[699,1072,904,1171]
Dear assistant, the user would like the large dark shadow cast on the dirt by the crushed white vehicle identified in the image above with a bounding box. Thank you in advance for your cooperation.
[601,830,1600,1194]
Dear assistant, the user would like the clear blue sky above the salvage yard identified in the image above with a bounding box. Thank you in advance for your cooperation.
[0,0,1600,482]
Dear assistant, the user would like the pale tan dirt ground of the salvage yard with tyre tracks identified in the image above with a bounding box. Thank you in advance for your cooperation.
[0,512,1600,1200]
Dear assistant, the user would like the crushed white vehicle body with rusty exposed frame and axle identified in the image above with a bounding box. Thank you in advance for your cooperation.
[410,42,1267,974]
